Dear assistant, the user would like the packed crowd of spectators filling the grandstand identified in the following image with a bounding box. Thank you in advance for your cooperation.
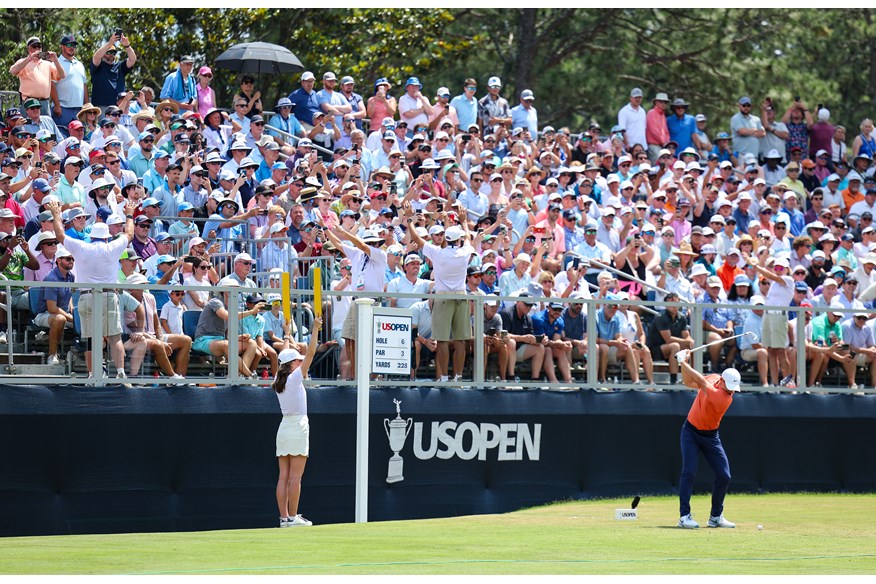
[0,31,876,388]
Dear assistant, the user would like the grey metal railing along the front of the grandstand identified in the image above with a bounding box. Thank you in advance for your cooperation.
[0,281,873,393]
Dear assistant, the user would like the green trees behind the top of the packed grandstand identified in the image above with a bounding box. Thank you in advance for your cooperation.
[0,8,876,132]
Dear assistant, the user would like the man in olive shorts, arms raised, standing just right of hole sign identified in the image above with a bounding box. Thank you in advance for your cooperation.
[410,223,475,381]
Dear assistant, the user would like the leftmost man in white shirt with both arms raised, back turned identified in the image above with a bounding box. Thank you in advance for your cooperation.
[46,202,136,379]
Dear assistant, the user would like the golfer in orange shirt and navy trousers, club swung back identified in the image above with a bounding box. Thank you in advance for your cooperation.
[675,349,742,529]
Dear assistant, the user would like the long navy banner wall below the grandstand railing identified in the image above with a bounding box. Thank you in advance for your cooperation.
[0,386,876,536]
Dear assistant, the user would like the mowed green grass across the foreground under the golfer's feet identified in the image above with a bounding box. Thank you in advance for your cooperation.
[0,494,876,574]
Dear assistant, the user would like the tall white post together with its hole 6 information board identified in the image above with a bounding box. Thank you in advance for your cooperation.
[355,298,413,523]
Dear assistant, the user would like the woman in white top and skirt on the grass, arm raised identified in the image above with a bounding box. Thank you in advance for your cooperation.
[271,317,322,527]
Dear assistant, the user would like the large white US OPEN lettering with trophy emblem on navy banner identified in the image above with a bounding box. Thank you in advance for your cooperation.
[383,400,541,483]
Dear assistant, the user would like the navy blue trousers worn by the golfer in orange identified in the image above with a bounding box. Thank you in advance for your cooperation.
[678,421,730,517]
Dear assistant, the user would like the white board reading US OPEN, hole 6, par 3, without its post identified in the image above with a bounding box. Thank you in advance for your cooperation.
[371,308,414,375]
